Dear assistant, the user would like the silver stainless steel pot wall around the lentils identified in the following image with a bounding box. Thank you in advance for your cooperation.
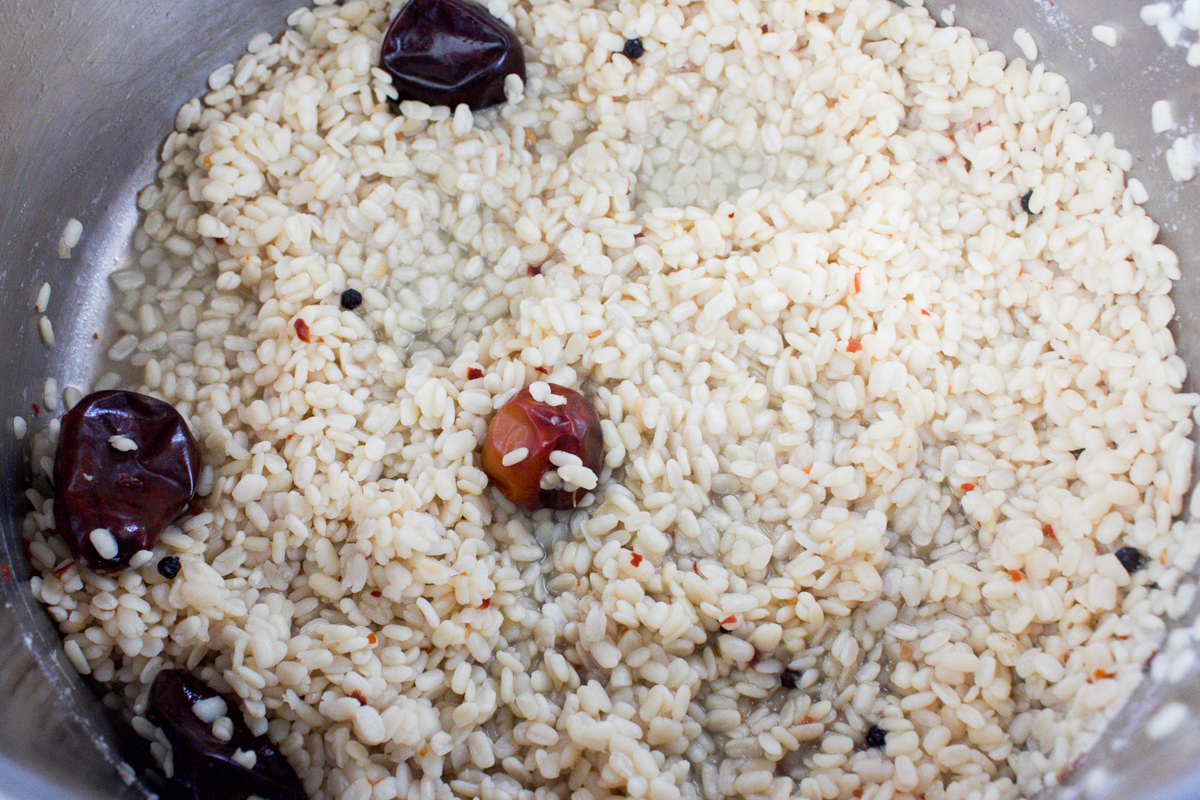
[0,0,1200,800]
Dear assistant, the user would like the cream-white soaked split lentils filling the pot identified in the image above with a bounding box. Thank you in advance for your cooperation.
[26,0,1200,800]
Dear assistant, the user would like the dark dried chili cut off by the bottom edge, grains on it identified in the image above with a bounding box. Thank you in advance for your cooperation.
[149,669,307,800]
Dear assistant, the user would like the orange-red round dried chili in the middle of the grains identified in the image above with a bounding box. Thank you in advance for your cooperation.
[484,384,604,511]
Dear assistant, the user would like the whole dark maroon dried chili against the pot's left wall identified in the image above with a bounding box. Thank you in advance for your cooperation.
[54,391,200,572]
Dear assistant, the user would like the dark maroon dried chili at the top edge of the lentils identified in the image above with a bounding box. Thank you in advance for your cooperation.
[380,0,526,109]
